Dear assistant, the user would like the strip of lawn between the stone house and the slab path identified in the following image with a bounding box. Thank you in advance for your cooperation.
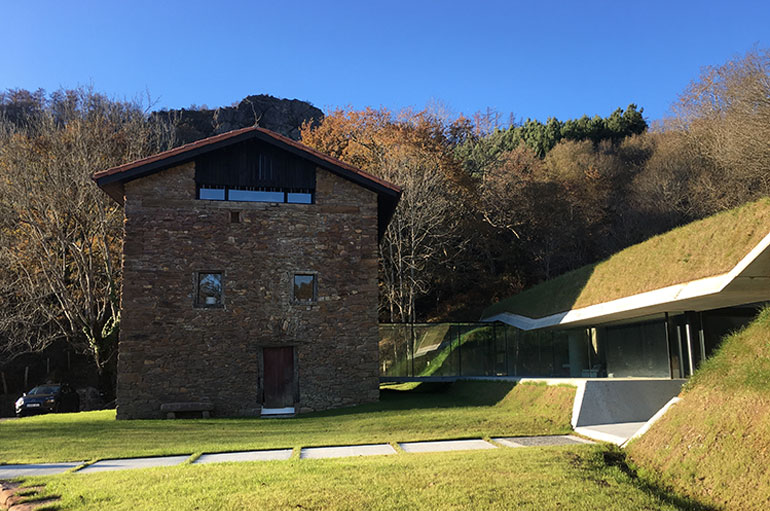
[0,382,575,464]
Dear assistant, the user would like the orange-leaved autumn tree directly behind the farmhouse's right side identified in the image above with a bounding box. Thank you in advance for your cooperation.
[302,109,468,322]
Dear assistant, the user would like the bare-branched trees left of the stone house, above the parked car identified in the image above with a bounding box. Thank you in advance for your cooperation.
[0,88,166,372]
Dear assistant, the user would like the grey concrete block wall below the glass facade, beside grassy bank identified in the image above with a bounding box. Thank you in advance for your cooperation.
[572,379,687,428]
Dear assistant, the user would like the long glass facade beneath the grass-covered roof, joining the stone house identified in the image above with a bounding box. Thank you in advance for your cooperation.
[380,307,758,378]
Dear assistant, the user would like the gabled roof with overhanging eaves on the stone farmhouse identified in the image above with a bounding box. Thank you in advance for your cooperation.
[92,127,401,236]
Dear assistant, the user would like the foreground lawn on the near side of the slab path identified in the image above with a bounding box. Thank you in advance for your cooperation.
[22,446,698,511]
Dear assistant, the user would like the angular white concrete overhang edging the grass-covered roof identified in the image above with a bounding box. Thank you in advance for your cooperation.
[482,229,770,330]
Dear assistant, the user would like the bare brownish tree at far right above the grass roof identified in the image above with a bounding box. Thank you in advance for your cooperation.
[666,49,770,216]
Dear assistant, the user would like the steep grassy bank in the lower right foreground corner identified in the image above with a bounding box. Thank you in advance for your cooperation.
[628,308,770,510]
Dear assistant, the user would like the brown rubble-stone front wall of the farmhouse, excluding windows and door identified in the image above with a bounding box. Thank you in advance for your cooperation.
[117,163,379,419]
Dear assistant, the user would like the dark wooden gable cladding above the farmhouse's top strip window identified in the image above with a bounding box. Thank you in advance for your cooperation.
[195,139,316,192]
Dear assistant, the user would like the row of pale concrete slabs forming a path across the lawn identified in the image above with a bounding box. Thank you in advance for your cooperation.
[0,435,593,479]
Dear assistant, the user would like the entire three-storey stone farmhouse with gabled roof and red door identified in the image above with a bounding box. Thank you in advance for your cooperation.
[93,127,401,419]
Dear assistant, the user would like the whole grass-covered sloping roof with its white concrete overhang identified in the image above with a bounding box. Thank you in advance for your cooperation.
[482,199,770,330]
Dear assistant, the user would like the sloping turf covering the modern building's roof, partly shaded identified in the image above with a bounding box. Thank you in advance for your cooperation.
[483,198,770,318]
